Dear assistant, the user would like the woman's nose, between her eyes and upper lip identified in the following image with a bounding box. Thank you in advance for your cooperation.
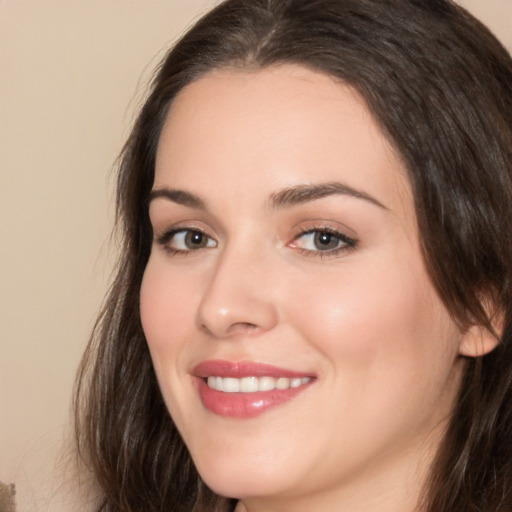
[198,248,278,338]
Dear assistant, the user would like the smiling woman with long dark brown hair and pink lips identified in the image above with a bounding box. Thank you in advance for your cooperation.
[76,0,512,512]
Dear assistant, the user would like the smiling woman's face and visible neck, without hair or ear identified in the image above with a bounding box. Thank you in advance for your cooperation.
[141,65,463,511]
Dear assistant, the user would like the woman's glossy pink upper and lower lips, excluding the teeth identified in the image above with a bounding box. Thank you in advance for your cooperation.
[192,360,315,419]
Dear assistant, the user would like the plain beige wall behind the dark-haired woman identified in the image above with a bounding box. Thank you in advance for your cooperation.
[0,0,512,512]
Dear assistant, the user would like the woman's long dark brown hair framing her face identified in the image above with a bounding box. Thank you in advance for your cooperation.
[76,0,512,512]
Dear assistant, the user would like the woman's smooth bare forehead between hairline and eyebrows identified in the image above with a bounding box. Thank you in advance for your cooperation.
[155,65,410,217]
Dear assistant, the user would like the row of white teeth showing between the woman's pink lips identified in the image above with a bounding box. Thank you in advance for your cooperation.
[206,376,311,393]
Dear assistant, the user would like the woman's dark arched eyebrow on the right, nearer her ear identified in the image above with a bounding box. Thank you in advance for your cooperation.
[270,181,388,210]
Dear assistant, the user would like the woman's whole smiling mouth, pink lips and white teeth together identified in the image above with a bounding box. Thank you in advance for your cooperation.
[192,361,316,419]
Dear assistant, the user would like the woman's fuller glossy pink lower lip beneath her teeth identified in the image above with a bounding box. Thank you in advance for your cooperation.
[198,379,311,419]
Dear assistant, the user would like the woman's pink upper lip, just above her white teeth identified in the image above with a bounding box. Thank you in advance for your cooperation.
[192,359,314,379]
